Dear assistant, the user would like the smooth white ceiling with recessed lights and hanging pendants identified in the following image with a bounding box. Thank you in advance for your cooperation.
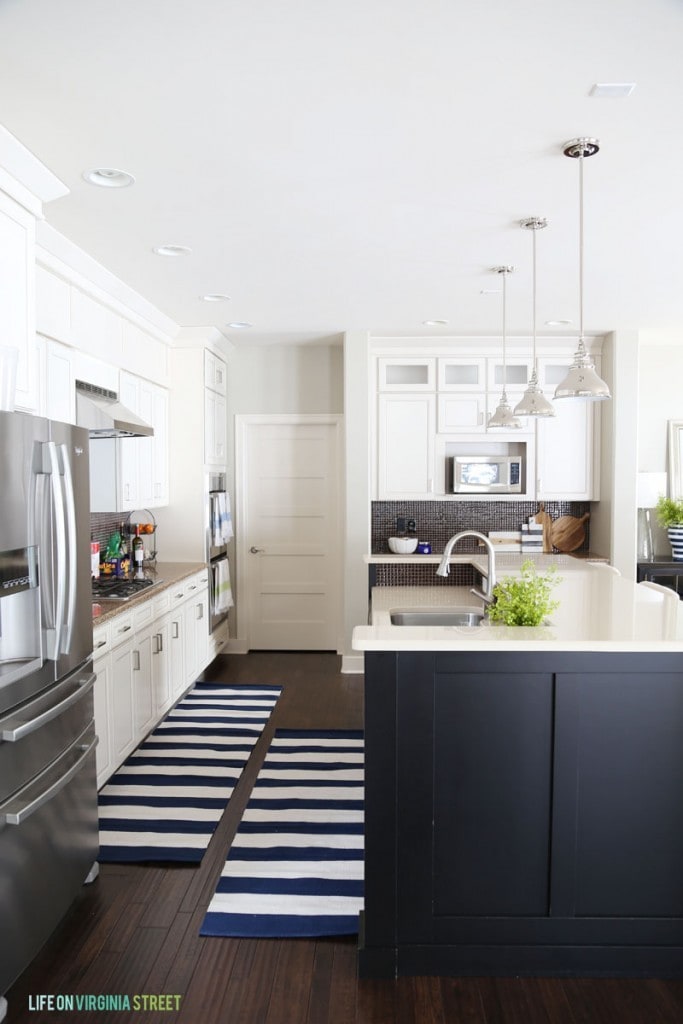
[0,0,683,344]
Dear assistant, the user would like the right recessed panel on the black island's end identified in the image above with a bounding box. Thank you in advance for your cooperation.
[552,671,683,921]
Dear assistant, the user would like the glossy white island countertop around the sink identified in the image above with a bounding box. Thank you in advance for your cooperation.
[352,554,683,652]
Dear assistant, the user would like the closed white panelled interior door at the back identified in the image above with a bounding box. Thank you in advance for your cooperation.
[241,417,342,650]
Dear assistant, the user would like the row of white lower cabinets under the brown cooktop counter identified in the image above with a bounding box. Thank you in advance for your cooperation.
[93,569,213,786]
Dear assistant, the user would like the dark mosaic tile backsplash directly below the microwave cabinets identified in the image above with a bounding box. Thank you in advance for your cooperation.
[372,501,591,555]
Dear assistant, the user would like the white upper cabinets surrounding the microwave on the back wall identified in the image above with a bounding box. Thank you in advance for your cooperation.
[371,339,599,501]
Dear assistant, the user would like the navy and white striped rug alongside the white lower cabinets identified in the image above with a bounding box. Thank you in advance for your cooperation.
[98,683,282,863]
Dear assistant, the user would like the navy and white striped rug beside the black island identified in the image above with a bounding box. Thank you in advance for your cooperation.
[200,729,364,938]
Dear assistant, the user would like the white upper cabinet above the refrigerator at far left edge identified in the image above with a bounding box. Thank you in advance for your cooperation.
[0,193,38,412]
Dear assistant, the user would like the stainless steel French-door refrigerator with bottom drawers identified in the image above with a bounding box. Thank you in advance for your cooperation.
[0,412,98,1020]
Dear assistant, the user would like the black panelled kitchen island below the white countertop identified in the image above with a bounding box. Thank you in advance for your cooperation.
[357,581,683,977]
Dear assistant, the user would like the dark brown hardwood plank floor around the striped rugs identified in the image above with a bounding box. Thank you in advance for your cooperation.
[7,653,683,1024]
